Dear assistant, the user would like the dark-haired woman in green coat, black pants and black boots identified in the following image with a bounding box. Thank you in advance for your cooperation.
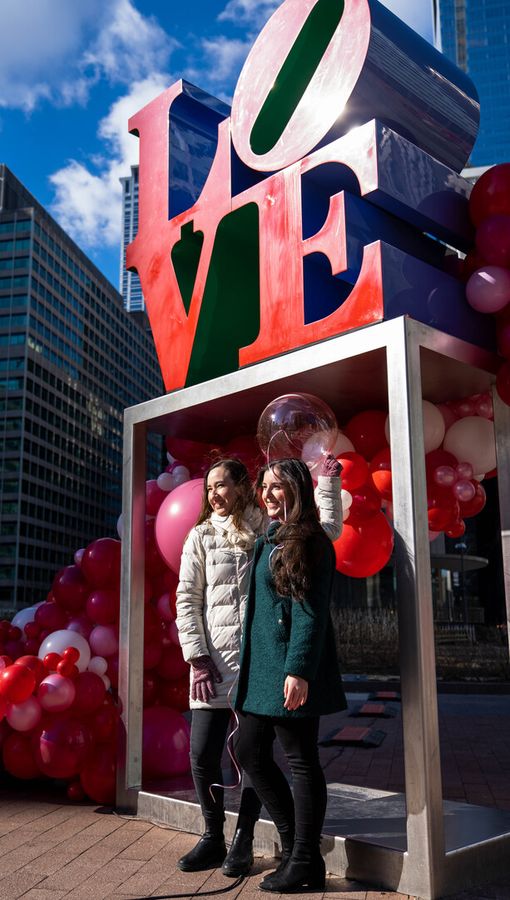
[236,459,346,893]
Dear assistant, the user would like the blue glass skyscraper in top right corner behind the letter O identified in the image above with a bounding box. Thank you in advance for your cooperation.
[439,0,510,166]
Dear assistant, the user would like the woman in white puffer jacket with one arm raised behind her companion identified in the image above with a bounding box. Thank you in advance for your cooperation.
[177,457,342,877]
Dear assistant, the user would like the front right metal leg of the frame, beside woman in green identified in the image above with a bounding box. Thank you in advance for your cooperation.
[387,319,445,897]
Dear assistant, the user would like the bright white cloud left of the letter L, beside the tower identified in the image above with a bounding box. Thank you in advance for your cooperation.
[50,75,169,249]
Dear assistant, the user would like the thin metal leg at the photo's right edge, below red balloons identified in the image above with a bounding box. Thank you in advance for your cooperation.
[492,388,510,654]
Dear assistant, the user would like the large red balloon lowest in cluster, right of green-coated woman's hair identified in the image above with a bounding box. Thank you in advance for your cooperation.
[334,512,393,578]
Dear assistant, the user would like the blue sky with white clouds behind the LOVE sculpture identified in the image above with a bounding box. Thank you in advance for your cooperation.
[0,0,431,285]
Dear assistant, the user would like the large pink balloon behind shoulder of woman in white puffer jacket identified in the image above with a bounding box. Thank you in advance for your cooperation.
[155,478,204,573]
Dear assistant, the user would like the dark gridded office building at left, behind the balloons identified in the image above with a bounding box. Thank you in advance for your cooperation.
[0,165,163,617]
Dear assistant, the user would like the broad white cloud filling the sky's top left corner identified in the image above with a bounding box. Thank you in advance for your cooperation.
[0,0,176,113]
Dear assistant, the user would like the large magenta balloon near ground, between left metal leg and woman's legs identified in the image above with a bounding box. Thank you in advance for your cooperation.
[142,706,189,778]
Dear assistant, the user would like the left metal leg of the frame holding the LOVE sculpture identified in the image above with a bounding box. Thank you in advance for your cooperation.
[117,410,146,812]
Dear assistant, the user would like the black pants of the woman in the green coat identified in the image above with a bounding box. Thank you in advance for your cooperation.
[236,712,327,861]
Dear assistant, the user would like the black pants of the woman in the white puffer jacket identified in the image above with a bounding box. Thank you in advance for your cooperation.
[191,709,261,834]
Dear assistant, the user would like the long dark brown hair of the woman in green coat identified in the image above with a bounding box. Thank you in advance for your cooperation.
[257,459,330,600]
